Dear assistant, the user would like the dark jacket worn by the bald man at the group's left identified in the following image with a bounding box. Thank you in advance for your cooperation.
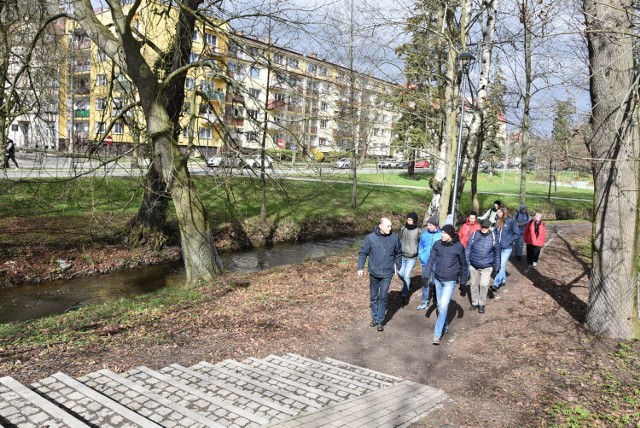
[358,226,402,278]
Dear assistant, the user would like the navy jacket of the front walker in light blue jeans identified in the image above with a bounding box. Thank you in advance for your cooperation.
[425,233,467,281]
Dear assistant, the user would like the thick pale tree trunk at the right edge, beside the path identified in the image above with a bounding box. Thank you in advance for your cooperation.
[584,0,640,339]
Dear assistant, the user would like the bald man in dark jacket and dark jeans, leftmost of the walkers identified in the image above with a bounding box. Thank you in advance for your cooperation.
[358,217,402,331]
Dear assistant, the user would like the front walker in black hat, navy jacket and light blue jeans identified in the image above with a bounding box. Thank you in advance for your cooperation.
[426,224,467,345]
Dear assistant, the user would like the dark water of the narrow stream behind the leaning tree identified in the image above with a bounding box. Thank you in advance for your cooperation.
[0,237,362,323]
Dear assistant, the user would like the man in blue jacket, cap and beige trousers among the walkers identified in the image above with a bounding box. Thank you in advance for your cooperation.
[465,218,500,314]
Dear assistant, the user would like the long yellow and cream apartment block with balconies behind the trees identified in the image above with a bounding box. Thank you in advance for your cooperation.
[53,0,400,157]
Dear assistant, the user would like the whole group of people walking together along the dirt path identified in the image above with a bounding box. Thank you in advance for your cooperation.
[358,200,546,345]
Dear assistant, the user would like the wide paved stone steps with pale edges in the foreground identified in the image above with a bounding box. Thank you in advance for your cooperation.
[0,354,448,428]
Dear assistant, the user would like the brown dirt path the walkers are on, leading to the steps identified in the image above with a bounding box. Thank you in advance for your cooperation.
[320,223,597,427]
